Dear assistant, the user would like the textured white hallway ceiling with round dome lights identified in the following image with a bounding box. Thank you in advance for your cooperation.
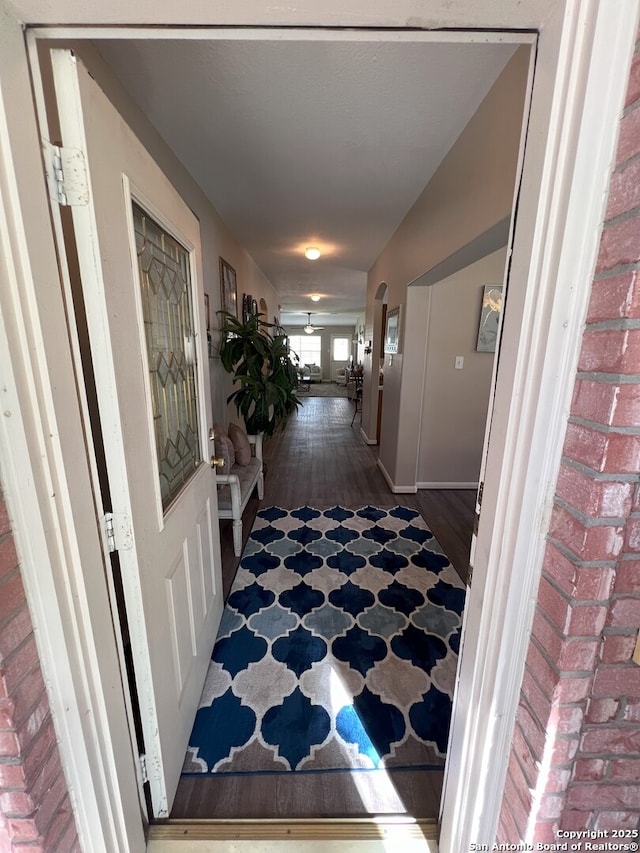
[96,40,514,324]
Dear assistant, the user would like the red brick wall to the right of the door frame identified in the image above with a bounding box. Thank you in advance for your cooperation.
[499,31,640,843]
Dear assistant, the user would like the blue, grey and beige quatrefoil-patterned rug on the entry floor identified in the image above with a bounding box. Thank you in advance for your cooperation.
[183,506,464,774]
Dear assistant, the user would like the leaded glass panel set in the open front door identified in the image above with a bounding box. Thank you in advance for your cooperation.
[133,204,201,509]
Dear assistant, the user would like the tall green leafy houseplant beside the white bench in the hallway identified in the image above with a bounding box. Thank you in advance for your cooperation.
[219,311,300,438]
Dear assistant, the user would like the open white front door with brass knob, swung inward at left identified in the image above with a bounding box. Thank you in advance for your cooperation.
[52,50,222,817]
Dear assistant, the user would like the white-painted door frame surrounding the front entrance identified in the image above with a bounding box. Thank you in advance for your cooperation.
[0,0,637,851]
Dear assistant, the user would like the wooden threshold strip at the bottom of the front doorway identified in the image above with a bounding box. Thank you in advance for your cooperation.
[148,817,437,844]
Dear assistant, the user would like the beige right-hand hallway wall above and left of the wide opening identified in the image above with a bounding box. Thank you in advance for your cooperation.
[362,47,529,490]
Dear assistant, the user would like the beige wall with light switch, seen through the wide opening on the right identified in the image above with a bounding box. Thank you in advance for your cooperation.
[418,248,506,488]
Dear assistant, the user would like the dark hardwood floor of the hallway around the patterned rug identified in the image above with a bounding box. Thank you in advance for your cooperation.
[171,397,475,819]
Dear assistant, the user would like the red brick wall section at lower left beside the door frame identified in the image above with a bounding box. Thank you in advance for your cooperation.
[0,486,80,853]
